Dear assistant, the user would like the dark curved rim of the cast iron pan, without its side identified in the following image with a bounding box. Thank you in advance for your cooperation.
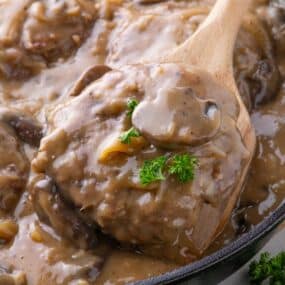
[136,203,285,285]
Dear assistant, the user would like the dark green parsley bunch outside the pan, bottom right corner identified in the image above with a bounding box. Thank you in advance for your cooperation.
[249,251,285,285]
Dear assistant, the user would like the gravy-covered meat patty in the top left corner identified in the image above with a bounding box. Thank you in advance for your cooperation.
[0,0,96,79]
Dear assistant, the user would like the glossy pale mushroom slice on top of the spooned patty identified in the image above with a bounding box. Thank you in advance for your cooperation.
[132,87,221,146]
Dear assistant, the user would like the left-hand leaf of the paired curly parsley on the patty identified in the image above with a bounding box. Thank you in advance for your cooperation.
[139,156,167,185]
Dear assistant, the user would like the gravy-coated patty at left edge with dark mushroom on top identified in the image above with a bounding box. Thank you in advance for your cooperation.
[0,107,41,212]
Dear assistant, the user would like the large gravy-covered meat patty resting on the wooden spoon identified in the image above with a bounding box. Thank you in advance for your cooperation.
[32,64,248,262]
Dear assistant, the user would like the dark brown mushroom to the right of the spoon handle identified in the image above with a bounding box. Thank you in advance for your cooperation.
[234,15,281,109]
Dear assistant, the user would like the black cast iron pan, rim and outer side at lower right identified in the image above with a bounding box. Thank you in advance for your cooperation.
[136,203,285,285]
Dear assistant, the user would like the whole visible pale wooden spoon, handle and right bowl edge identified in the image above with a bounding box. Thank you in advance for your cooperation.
[162,0,256,234]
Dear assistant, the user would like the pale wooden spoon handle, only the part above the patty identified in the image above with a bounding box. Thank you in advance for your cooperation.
[163,0,252,74]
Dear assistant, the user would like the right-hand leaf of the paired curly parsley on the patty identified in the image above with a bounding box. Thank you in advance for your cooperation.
[169,154,198,183]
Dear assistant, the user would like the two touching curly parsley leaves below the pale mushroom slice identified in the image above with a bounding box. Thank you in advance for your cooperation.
[139,154,198,185]
